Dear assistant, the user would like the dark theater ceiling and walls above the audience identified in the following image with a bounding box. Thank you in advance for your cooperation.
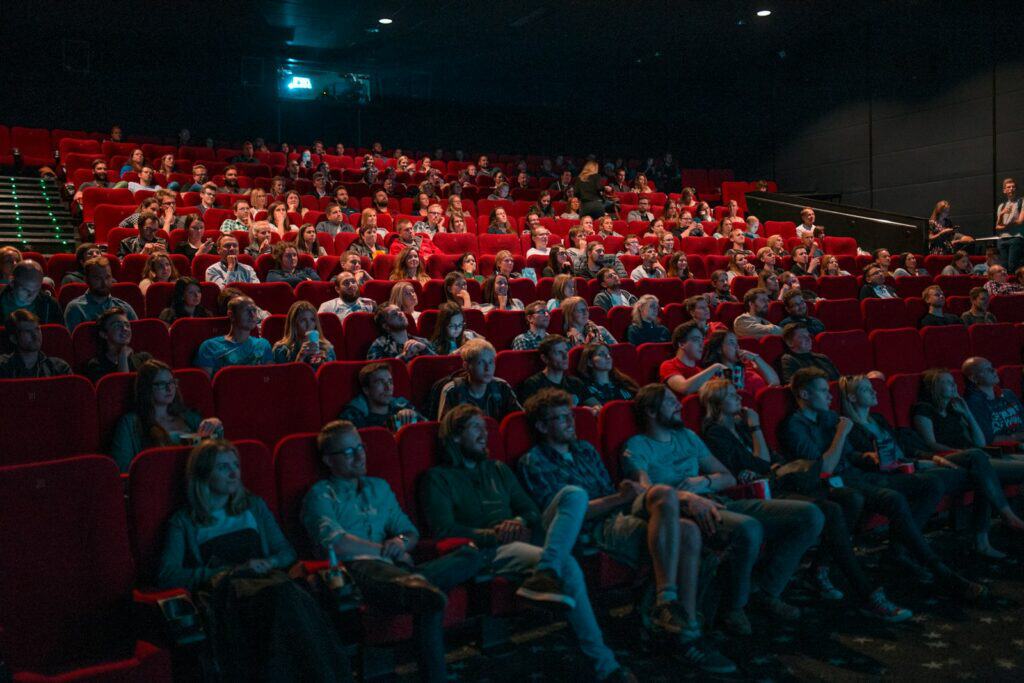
[0,0,1024,234]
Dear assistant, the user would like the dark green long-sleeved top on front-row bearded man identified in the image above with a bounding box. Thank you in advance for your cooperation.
[421,440,544,547]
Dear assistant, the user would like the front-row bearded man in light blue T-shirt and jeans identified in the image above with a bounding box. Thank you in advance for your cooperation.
[623,384,824,635]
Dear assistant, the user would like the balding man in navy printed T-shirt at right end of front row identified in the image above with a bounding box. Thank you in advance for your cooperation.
[961,356,1024,443]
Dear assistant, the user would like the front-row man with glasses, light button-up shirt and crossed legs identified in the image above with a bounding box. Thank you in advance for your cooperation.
[302,420,484,682]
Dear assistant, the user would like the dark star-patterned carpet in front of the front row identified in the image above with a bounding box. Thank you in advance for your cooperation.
[400,526,1024,683]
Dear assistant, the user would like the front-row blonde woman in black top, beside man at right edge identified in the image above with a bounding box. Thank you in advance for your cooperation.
[909,369,1024,558]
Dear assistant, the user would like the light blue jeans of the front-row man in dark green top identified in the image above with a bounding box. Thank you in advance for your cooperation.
[492,486,618,678]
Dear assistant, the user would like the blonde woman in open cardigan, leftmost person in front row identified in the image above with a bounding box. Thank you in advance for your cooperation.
[157,439,351,682]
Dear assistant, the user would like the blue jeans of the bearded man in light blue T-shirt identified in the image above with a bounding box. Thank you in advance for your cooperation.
[720,499,825,609]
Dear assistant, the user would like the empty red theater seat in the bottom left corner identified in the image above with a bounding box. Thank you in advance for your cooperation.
[0,456,171,681]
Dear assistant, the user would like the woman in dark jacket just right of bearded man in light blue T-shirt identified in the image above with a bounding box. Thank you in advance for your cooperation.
[700,378,913,623]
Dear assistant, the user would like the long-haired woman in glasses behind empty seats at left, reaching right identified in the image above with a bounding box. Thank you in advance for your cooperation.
[111,360,224,472]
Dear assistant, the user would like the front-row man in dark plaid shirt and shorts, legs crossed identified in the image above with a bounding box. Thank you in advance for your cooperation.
[518,389,736,674]
